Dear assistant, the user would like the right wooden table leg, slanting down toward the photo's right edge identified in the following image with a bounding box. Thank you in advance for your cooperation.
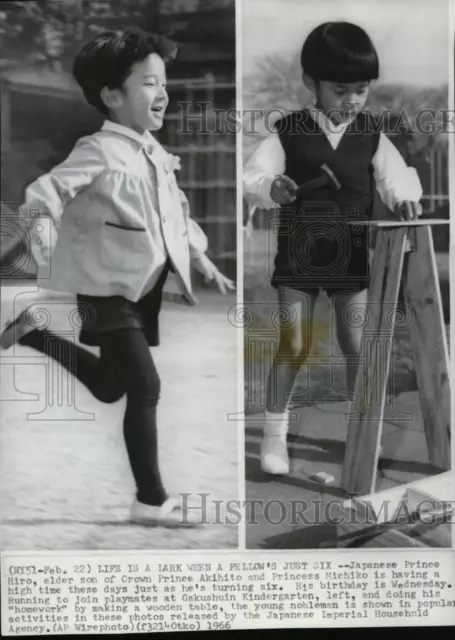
[403,226,450,470]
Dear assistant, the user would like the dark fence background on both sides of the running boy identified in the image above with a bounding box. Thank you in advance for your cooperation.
[0,76,236,278]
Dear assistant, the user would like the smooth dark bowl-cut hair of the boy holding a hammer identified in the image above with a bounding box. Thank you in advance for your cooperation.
[300,22,379,82]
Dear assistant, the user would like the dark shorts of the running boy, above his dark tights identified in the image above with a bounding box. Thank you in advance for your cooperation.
[77,264,169,347]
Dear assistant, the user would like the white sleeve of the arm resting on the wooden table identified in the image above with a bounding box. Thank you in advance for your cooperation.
[373,133,423,211]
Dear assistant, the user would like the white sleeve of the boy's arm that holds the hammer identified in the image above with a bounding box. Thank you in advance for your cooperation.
[243,133,286,209]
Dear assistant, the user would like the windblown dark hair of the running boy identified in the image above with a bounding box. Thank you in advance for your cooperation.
[73,29,177,115]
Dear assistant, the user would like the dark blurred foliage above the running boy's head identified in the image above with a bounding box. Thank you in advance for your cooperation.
[0,0,235,75]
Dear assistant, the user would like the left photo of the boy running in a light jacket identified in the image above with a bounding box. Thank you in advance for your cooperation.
[0,0,243,551]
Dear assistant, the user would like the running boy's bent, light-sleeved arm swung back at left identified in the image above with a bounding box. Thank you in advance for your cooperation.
[19,136,105,265]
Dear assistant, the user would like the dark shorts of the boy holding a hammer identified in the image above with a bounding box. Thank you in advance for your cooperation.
[271,225,370,296]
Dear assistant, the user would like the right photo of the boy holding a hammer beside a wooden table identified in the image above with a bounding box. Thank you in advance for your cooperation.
[242,0,453,549]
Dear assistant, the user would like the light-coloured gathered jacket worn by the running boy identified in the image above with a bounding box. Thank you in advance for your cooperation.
[20,121,207,304]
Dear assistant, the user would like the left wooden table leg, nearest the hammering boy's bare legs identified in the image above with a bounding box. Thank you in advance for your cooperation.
[341,228,408,495]
